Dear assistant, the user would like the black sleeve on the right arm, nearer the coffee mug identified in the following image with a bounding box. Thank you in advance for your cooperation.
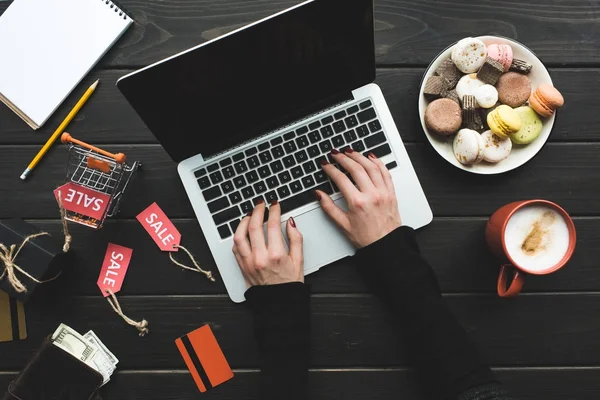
[354,227,509,400]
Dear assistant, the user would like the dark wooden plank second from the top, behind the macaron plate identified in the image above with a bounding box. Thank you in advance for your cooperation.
[0,68,600,145]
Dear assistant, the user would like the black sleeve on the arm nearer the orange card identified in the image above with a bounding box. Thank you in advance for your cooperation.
[246,282,310,400]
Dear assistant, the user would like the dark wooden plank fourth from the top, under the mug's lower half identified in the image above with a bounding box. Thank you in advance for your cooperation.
[19,217,600,299]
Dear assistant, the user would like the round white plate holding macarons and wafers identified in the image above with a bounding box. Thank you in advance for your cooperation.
[419,36,556,175]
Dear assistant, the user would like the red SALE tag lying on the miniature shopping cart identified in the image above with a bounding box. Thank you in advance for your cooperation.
[54,182,110,219]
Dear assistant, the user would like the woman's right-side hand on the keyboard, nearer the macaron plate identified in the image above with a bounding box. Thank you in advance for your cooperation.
[316,148,402,248]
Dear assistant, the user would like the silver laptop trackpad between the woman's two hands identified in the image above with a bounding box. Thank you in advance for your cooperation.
[281,198,356,273]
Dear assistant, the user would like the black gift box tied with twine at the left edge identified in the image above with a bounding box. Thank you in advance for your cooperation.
[0,219,71,302]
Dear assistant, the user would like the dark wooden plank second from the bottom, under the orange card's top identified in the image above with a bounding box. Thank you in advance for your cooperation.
[0,292,600,370]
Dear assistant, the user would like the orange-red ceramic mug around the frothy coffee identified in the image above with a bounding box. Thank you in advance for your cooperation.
[485,200,577,297]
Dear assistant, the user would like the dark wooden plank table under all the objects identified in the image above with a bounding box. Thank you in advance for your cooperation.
[0,0,600,400]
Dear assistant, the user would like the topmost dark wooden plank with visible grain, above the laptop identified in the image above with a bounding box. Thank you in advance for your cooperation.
[0,0,600,67]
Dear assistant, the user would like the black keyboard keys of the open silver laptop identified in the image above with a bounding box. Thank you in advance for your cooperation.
[195,100,397,239]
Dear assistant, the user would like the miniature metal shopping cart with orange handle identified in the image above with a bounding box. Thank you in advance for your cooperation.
[61,132,141,229]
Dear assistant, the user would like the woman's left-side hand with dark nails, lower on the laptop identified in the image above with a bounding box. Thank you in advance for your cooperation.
[233,201,304,287]
